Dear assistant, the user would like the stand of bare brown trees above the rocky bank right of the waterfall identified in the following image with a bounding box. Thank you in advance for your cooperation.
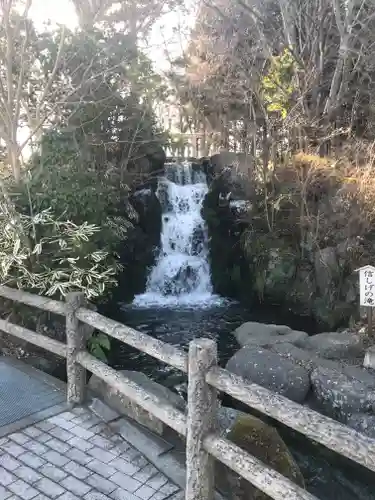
[176,0,375,151]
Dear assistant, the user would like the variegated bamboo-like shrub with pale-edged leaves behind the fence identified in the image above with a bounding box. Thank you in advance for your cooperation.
[0,202,118,299]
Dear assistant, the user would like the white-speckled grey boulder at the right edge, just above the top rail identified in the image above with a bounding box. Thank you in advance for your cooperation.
[310,366,375,422]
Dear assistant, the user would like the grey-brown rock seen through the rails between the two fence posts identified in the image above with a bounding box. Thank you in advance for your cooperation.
[89,370,185,435]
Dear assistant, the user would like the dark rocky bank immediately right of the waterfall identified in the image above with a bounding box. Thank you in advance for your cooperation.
[204,153,364,328]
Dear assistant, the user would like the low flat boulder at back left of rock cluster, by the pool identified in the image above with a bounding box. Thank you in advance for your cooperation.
[234,321,308,347]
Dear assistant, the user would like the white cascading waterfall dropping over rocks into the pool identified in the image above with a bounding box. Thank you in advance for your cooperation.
[133,163,220,306]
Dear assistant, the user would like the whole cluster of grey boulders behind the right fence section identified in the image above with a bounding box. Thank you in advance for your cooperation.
[226,323,375,437]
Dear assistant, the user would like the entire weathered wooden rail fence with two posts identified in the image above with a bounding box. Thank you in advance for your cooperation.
[0,286,375,500]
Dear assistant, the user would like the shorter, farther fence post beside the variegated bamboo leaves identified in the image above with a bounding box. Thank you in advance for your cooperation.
[66,292,86,404]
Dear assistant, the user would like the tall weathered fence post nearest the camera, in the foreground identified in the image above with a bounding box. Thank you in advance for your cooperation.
[185,339,217,500]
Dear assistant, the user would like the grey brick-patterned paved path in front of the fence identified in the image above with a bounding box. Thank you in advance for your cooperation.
[0,408,183,500]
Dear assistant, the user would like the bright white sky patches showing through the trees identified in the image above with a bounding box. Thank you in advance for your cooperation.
[30,0,197,73]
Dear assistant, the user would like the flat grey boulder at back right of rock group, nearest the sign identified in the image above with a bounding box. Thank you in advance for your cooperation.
[295,332,365,359]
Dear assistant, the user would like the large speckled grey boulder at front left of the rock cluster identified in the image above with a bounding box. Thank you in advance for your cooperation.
[226,345,310,403]
